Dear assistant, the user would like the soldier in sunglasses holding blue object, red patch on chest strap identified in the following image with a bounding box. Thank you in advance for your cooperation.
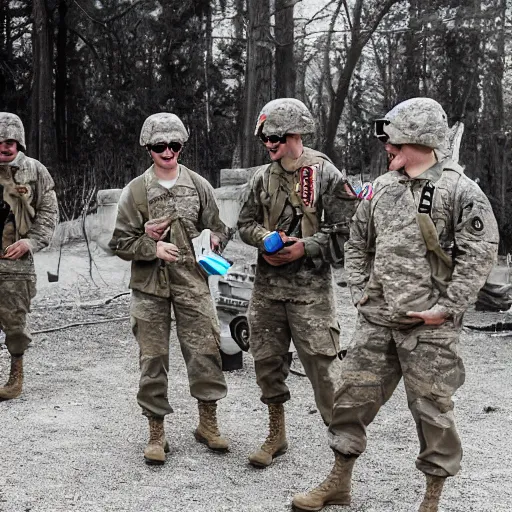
[238,98,356,467]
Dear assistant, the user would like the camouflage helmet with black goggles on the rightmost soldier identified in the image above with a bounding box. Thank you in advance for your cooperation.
[375,98,448,149]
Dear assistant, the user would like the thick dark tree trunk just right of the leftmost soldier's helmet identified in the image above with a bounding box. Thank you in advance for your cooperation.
[29,0,57,166]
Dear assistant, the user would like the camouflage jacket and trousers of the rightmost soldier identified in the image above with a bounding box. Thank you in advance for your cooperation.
[329,160,498,477]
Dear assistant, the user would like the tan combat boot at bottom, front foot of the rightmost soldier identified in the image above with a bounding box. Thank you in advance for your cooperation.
[292,452,357,510]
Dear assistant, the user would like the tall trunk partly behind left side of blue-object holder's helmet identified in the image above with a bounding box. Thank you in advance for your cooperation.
[241,0,272,167]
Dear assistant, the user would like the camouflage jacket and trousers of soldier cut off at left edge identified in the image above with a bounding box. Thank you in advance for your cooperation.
[0,150,58,355]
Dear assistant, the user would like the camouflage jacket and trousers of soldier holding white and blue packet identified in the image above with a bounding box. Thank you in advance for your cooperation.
[110,165,229,417]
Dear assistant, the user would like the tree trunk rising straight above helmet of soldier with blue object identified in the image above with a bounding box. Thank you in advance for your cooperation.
[275,0,296,98]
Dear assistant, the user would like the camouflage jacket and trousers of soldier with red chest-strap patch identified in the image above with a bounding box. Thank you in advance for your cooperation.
[238,146,356,423]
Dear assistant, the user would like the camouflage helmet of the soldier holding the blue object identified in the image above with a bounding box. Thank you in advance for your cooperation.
[254,98,315,136]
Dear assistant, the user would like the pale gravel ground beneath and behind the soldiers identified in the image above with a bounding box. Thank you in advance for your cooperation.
[0,243,512,512]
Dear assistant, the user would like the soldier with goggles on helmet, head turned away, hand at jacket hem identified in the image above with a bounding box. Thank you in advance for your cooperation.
[293,98,498,512]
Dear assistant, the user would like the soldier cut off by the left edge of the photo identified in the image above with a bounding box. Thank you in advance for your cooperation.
[0,112,58,400]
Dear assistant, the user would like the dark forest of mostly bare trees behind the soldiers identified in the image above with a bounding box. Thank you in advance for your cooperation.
[0,0,512,252]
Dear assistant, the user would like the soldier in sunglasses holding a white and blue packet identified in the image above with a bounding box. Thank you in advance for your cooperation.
[110,113,230,464]
